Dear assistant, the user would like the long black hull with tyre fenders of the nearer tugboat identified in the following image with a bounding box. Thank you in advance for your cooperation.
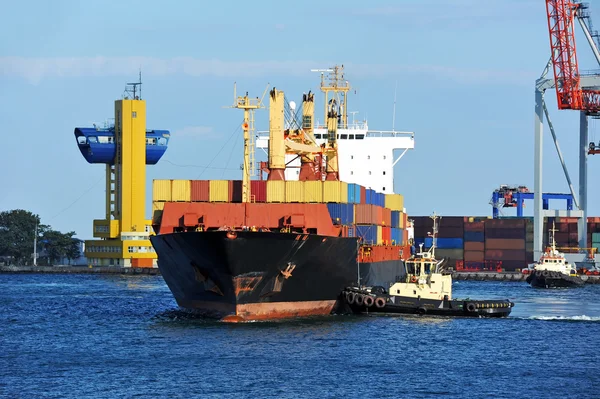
[342,288,514,317]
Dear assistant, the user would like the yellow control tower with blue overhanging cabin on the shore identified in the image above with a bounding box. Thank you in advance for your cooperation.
[75,83,170,267]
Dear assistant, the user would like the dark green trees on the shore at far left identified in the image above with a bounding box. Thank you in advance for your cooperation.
[0,209,80,266]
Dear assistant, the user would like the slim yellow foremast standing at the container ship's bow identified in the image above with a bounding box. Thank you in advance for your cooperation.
[230,83,266,202]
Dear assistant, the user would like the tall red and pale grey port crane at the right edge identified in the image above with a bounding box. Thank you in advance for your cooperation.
[534,0,600,257]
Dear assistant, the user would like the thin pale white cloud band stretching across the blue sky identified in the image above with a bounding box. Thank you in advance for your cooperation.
[0,56,539,84]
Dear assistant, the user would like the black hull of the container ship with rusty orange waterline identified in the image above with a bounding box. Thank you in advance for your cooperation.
[151,231,402,321]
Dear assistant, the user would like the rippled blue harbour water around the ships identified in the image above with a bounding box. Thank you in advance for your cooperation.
[0,274,600,399]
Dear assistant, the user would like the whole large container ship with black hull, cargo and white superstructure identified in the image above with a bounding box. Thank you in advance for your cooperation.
[151,66,414,321]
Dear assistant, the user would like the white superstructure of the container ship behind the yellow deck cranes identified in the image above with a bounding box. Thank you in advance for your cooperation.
[256,122,415,194]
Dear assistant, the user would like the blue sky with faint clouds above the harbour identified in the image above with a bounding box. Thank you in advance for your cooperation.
[0,0,600,239]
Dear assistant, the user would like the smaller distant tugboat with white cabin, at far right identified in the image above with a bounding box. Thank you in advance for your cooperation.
[525,224,585,288]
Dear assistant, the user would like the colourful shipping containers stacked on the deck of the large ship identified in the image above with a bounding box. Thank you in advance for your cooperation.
[152,180,408,245]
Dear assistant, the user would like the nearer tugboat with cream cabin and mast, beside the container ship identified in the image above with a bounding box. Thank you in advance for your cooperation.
[342,213,514,317]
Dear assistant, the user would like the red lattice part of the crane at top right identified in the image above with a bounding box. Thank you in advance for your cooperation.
[546,0,600,112]
